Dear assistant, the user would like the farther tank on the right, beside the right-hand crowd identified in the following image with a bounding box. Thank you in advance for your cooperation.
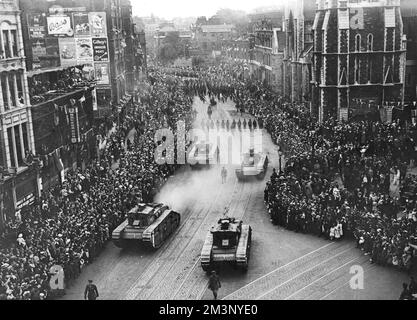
[235,148,269,181]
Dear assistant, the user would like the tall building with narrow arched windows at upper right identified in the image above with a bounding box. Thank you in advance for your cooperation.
[312,0,406,121]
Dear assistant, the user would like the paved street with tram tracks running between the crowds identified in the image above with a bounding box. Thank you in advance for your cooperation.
[63,97,408,300]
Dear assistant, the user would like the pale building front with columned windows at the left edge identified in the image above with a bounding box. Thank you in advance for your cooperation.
[0,0,38,228]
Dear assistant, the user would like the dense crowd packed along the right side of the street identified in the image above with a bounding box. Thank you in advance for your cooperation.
[176,64,417,272]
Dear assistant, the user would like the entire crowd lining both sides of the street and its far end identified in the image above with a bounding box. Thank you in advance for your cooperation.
[0,60,417,300]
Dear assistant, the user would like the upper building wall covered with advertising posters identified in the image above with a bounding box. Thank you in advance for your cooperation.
[20,0,131,117]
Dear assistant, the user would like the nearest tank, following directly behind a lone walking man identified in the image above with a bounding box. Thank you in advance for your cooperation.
[201,218,252,272]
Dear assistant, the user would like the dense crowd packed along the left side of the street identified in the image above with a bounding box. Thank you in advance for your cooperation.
[0,69,193,300]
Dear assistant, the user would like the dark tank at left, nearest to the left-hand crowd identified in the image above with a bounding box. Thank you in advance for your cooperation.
[112,203,181,249]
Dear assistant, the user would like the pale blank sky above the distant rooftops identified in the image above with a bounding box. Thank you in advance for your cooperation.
[131,0,285,19]
